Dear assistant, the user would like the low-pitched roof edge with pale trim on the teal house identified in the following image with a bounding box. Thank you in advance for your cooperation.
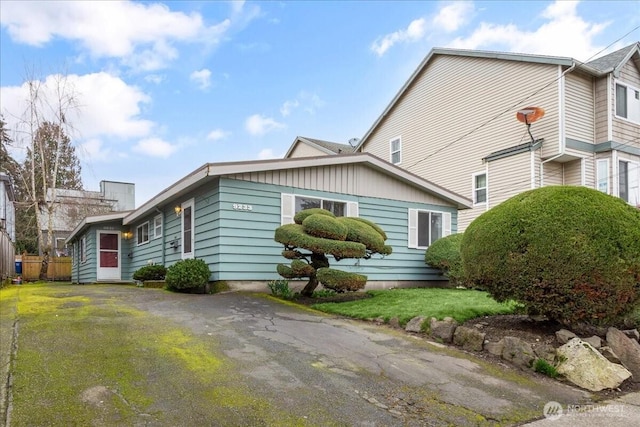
[123,153,471,225]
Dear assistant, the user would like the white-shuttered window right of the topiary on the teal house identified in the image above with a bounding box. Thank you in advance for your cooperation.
[408,209,451,249]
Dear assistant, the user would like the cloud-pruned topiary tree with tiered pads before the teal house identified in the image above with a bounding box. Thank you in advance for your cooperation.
[274,208,391,296]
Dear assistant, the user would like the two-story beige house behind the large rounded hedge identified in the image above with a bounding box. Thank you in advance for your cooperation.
[356,43,640,231]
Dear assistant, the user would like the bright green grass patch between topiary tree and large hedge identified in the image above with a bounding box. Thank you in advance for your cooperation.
[313,288,518,325]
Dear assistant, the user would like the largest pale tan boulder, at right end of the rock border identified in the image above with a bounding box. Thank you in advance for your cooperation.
[556,337,631,391]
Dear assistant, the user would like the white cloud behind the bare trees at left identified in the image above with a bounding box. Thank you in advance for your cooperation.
[0,72,155,144]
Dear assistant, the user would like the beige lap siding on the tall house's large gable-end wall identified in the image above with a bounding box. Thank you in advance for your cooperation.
[362,55,561,229]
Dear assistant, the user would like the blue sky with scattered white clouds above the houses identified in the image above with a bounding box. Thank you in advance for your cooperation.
[0,0,640,205]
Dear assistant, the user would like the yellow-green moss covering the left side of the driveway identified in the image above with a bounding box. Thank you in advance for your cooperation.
[0,285,309,427]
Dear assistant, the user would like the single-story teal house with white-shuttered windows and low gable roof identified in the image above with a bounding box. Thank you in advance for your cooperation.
[67,153,471,289]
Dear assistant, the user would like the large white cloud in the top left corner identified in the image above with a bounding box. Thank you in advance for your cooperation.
[0,1,231,70]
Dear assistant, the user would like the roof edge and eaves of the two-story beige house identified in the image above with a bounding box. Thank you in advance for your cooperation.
[355,43,640,151]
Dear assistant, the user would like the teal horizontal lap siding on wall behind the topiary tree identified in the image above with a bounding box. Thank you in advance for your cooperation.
[212,179,457,281]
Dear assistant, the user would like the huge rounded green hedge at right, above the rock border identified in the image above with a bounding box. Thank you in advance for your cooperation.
[461,186,640,326]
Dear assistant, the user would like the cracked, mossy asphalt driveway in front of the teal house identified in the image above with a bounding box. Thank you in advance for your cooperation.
[2,285,588,426]
